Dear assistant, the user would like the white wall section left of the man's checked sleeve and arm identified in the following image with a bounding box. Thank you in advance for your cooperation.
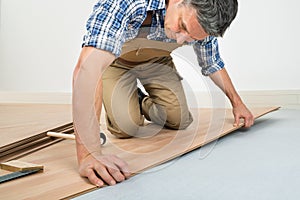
[0,0,95,92]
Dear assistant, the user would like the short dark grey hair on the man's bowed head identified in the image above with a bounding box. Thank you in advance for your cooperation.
[183,0,238,36]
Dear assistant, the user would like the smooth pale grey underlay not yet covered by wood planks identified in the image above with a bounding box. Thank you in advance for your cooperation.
[75,109,300,200]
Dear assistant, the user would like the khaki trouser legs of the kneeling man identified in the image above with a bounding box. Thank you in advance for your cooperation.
[102,56,193,138]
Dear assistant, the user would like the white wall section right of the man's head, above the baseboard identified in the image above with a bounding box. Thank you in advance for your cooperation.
[221,0,300,90]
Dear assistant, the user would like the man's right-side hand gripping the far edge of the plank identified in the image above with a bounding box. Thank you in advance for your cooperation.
[232,103,254,128]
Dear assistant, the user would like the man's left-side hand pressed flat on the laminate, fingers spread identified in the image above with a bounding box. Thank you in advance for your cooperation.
[79,154,130,187]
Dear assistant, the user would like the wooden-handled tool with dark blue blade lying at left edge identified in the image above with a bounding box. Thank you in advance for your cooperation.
[0,160,44,184]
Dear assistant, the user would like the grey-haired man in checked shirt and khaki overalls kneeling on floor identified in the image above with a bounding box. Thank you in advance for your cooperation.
[73,0,253,187]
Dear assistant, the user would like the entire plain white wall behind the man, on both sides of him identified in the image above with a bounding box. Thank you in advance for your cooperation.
[0,0,300,92]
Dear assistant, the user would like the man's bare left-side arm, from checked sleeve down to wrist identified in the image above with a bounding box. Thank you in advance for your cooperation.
[73,48,115,162]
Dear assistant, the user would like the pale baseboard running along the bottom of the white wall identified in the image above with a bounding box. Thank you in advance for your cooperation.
[0,90,300,109]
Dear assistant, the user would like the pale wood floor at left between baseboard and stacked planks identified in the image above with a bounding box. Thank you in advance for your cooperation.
[0,104,72,148]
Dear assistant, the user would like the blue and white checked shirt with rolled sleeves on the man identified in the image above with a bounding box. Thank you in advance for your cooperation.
[83,0,224,76]
